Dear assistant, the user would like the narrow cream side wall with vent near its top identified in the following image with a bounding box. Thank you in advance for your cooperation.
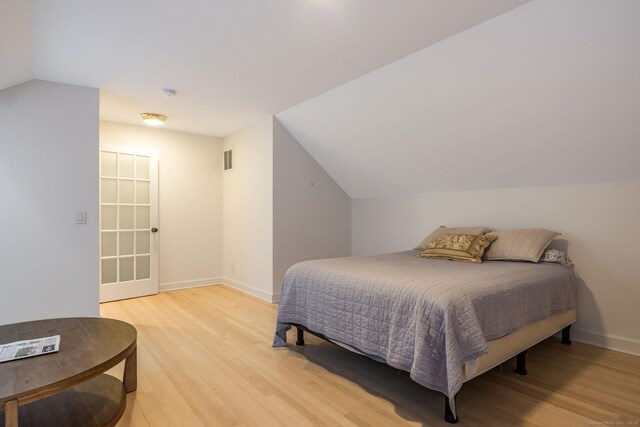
[222,117,273,301]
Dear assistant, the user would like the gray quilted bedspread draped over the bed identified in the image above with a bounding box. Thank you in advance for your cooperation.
[273,250,576,397]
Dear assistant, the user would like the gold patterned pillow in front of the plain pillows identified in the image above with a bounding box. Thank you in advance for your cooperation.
[418,234,496,264]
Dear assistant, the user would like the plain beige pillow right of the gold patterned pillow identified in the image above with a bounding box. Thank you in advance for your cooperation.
[485,228,560,262]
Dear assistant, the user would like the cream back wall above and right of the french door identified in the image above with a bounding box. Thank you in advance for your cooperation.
[100,121,222,290]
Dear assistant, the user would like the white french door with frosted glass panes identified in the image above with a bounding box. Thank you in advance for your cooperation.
[100,145,158,302]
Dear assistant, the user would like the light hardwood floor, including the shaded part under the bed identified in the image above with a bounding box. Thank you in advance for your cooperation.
[101,286,640,427]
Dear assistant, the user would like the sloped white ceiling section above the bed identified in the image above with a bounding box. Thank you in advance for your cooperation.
[276,0,640,199]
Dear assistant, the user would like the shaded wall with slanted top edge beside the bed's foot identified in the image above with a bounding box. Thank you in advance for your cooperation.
[273,118,351,296]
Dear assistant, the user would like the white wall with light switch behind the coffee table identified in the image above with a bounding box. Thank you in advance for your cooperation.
[0,80,99,324]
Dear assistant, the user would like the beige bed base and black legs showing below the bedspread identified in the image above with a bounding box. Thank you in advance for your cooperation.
[291,310,576,424]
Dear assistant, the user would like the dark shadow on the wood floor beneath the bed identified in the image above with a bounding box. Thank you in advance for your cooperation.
[287,328,606,426]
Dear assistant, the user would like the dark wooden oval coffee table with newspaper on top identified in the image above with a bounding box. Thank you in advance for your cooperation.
[0,317,137,427]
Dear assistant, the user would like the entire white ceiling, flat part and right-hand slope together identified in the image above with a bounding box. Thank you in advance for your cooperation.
[0,0,640,198]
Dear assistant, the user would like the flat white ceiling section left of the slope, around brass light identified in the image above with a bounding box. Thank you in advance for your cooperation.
[0,0,526,136]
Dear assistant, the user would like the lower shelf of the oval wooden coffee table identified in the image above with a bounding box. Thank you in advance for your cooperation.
[0,374,127,427]
